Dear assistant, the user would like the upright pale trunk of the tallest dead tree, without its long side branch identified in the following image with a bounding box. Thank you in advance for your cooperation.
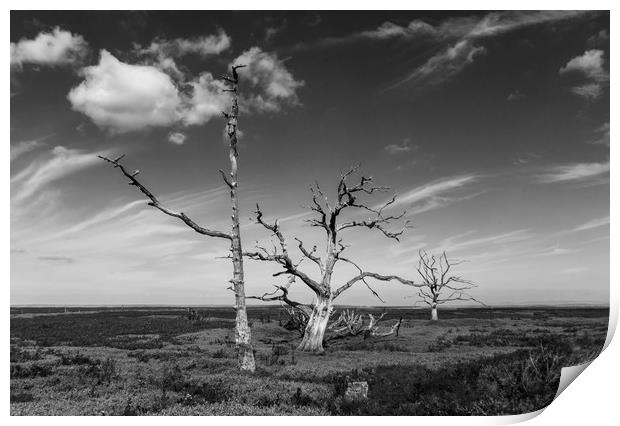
[222,68,256,371]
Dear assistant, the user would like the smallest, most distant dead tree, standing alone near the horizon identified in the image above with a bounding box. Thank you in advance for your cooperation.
[416,250,484,321]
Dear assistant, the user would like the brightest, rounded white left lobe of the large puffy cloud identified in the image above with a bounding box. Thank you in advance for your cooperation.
[68,50,181,133]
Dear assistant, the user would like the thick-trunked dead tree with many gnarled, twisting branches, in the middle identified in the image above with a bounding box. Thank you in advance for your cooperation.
[244,166,418,352]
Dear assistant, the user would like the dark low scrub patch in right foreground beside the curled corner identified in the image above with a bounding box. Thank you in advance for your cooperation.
[330,343,571,415]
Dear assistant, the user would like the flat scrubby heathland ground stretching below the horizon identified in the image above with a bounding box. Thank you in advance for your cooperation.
[11,307,609,415]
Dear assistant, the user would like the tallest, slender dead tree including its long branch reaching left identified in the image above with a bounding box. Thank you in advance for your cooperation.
[100,65,255,371]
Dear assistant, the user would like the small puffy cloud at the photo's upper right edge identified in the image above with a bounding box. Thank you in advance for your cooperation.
[559,49,609,101]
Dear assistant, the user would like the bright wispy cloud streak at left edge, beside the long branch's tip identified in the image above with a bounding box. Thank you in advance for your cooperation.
[11,146,109,203]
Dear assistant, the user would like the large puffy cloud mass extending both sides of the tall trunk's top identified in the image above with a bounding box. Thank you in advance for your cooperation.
[67,47,304,133]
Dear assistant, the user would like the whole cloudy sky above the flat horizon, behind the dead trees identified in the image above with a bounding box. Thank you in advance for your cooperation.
[10,11,610,306]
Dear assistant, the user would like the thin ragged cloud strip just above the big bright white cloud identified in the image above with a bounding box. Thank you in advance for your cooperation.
[136,29,231,58]
